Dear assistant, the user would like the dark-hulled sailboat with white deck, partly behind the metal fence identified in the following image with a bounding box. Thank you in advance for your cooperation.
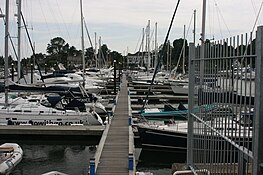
[133,108,254,153]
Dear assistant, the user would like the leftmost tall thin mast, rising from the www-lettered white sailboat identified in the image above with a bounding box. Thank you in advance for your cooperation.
[5,0,9,106]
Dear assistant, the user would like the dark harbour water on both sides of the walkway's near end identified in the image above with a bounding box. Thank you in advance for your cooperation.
[3,138,174,175]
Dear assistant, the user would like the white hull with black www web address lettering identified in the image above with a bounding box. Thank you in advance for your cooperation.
[0,103,102,126]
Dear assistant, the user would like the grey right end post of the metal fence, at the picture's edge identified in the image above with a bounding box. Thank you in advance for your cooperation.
[252,26,263,174]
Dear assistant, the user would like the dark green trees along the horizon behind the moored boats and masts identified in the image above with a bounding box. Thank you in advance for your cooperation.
[0,37,255,71]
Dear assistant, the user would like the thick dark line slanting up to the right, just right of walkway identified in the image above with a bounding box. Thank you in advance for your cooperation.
[142,0,180,109]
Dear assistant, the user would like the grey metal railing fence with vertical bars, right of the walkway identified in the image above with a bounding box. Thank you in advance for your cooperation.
[187,27,263,175]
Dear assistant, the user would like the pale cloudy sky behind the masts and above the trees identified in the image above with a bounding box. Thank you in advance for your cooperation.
[0,0,263,57]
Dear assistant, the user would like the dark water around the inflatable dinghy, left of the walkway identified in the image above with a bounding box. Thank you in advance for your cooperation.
[0,138,98,175]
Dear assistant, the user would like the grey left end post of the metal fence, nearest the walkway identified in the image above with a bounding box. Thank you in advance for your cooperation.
[187,43,195,166]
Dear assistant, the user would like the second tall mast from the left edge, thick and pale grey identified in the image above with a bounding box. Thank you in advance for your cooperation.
[17,0,22,82]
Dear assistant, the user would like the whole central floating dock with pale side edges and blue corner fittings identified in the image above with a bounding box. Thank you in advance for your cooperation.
[90,75,135,175]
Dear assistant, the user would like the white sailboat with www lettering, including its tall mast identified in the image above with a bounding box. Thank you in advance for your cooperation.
[0,0,103,126]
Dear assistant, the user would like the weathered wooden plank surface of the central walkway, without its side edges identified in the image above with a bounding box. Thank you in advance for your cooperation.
[96,75,134,175]
